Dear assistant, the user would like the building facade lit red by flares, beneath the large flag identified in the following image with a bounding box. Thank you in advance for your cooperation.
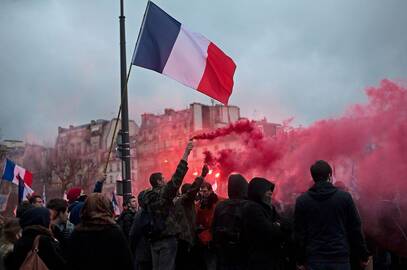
[134,103,280,191]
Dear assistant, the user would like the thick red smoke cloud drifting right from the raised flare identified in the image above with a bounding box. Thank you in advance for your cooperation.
[195,80,407,256]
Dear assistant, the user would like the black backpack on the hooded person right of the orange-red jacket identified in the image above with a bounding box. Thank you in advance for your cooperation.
[213,200,247,249]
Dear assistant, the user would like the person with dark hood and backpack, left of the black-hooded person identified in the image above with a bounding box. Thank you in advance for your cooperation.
[212,174,248,270]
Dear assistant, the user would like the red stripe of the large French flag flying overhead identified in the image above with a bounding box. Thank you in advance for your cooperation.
[198,42,236,105]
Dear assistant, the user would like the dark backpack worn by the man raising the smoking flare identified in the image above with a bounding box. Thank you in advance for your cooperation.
[143,190,169,241]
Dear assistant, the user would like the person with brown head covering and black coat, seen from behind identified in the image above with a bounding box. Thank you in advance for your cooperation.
[68,193,132,270]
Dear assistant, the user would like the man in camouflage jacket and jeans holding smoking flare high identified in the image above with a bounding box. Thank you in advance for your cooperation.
[143,141,193,270]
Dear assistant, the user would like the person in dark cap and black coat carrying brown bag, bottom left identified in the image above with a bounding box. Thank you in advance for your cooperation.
[6,207,66,270]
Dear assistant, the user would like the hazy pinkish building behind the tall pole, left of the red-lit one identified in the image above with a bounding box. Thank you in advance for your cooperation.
[54,119,138,196]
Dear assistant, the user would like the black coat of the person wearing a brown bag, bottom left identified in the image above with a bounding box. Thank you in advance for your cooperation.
[6,225,66,270]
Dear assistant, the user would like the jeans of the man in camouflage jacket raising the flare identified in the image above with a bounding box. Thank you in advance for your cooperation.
[151,237,178,270]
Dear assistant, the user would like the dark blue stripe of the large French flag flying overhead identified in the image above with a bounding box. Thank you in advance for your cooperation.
[132,1,181,73]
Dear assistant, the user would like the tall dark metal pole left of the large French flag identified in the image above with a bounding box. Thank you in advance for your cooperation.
[119,0,131,200]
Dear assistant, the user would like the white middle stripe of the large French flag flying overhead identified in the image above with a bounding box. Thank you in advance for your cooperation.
[163,25,210,89]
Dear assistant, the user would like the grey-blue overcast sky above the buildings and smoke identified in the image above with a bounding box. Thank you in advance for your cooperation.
[0,0,407,144]
